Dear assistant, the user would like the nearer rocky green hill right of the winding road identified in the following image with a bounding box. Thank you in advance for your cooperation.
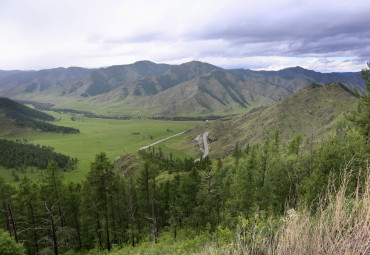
[189,83,357,157]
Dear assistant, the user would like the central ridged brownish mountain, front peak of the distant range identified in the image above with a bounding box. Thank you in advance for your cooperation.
[127,69,290,115]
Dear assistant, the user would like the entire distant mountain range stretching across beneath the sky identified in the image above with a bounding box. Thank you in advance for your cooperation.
[0,61,364,116]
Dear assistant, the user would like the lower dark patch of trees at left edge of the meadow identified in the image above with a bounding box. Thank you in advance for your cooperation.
[0,139,77,169]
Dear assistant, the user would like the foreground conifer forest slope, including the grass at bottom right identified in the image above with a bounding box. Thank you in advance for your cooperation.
[0,66,370,254]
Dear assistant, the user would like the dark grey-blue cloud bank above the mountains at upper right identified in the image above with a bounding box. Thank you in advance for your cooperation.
[191,5,370,58]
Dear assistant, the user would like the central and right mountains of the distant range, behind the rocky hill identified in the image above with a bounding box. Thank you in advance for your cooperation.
[91,62,363,116]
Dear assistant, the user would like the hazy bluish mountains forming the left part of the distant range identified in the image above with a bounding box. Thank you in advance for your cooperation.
[0,61,170,100]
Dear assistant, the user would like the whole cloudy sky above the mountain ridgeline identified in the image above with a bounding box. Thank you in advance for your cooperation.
[0,0,370,72]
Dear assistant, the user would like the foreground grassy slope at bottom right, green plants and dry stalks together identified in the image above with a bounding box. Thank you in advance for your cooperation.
[201,167,370,255]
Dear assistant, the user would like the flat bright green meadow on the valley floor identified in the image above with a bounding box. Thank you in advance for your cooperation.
[0,112,200,182]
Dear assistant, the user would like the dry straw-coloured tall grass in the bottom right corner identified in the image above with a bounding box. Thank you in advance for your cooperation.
[271,168,370,255]
